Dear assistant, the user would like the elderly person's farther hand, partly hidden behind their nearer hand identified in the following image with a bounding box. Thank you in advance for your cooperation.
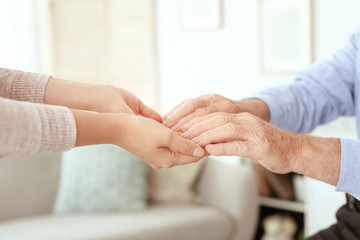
[163,94,270,131]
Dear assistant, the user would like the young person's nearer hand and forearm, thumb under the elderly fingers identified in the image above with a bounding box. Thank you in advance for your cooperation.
[73,110,204,168]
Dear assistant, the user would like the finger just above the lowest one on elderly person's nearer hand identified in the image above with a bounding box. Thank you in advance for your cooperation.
[192,123,250,147]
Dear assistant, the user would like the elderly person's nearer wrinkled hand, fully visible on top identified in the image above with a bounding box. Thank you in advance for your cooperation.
[181,113,300,173]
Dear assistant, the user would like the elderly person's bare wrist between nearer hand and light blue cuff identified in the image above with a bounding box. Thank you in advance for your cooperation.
[289,134,341,186]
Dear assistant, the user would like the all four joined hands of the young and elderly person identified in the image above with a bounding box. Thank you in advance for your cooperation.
[61,79,300,173]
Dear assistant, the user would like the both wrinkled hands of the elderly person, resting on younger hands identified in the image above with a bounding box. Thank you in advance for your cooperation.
[163,94,301,173]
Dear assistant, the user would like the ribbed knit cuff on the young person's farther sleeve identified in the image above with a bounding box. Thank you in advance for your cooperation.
[9,71,51,103]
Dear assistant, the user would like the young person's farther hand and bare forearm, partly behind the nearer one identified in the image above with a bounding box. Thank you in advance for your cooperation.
[45,78,161,122]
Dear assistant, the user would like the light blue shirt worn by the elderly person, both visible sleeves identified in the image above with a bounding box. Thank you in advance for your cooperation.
[253,31,360,199]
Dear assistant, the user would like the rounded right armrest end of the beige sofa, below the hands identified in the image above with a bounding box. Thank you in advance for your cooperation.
[197,158,259,240]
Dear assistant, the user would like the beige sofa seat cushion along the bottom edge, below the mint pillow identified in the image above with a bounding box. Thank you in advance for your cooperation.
[0,204,232,240]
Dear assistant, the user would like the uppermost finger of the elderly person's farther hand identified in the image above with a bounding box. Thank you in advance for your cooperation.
[163,99,204,128]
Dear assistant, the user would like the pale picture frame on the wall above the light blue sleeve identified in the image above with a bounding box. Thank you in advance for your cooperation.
[259,0,313,74]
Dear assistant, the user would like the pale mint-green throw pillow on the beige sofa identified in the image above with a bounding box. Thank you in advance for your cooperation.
[54,145,148,213]
